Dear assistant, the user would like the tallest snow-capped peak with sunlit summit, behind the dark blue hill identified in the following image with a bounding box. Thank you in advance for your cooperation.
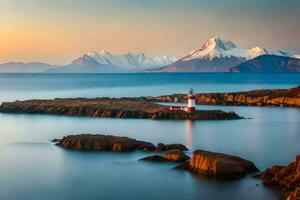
[160,37,288,72]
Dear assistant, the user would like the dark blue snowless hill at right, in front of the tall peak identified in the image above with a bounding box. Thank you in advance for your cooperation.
[230,55,300,73]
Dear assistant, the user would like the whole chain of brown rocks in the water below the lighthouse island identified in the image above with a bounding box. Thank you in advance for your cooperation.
[53,134,258,178]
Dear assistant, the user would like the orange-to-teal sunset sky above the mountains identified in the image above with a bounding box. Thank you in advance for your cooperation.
[0,0,300,64]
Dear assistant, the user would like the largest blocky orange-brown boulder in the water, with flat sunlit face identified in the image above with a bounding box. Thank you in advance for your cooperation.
[177,150,258,178]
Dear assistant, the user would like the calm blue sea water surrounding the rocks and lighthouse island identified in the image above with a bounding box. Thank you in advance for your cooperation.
[0,74,300,199]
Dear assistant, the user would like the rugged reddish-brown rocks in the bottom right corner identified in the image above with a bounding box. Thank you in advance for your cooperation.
[260,155,300,200]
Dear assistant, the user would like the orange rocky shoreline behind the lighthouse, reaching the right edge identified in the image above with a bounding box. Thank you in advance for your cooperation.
[143,86,300,107]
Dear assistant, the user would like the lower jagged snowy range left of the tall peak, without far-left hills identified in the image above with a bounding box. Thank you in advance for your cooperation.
[46,51,176,73]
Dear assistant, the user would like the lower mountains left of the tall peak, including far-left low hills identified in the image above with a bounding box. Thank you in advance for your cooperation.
[0,51,177,73]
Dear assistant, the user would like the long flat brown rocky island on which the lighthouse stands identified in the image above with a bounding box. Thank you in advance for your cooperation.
[0,98,241,120]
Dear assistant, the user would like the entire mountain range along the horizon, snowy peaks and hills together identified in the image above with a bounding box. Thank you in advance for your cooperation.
[0,37,300,73]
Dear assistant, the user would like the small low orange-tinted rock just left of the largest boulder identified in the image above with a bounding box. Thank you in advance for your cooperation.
[140,150,190,162]
